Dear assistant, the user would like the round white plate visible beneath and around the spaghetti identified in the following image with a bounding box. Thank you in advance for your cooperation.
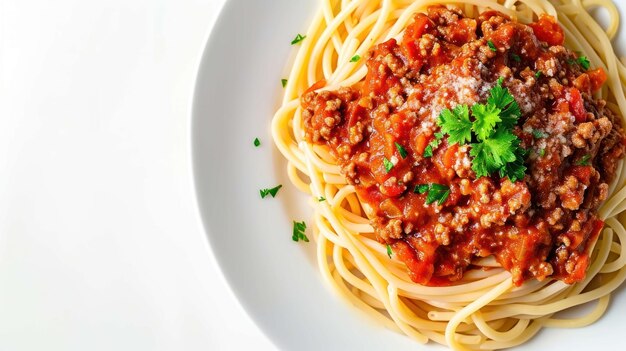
[192,0,626,351]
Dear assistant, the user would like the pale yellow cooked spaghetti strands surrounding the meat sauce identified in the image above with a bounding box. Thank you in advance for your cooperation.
[272,0,626,350]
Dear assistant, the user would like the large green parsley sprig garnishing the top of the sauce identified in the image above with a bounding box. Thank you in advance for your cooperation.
[437,78,527,182]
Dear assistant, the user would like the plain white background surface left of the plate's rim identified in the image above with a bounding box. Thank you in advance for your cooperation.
[0,0,273,350]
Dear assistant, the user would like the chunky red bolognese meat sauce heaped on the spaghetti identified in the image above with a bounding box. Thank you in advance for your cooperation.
[301,7,626,286]
